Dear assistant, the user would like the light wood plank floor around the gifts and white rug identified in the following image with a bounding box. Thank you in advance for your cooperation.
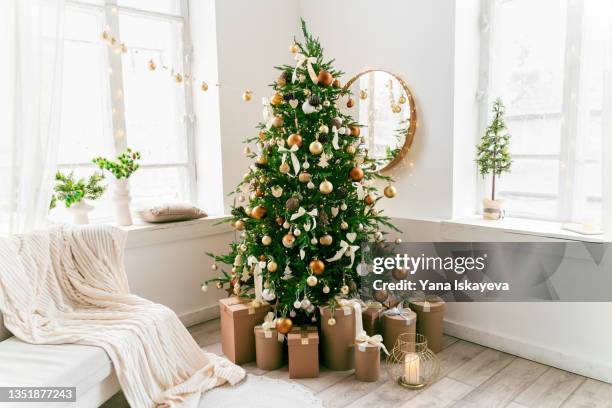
[104,320,612,408]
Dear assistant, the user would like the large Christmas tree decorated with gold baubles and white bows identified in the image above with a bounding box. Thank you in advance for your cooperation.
[203,20,395,332]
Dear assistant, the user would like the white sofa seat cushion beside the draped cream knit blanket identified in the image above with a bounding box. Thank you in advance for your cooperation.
[0,337,114,401]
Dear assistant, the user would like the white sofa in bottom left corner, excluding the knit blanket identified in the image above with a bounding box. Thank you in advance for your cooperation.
[0,314,120,408]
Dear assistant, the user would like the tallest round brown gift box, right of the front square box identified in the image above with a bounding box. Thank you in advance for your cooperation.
[320,303,362,371]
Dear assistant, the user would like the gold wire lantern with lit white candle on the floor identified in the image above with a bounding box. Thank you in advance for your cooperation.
[387,333,440,389]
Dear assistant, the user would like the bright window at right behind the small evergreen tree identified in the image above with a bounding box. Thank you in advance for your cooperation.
[481,0,612,226]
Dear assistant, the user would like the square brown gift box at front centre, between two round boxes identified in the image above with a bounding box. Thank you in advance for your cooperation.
[287,326,319,378]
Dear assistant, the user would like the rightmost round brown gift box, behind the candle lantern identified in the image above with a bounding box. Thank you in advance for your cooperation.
[409,296,446,353]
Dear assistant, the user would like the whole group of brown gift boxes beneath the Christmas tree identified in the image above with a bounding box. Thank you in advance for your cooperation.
[219,297,445,381]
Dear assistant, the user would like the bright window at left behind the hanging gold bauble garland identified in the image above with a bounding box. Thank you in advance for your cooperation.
[58,0,195,218]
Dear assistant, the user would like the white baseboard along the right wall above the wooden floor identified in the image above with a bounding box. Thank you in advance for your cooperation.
[444,319,612,384]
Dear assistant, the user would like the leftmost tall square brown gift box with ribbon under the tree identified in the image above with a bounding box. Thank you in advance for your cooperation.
[219,297,270,364]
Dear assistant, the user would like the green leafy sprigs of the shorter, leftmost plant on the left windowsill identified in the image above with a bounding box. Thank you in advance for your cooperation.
[49,171,106,209]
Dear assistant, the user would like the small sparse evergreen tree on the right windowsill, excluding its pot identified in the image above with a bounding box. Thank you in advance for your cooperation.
[476,98,512,199]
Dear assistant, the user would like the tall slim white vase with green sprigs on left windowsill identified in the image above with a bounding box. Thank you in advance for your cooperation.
[93,147,140,225]
